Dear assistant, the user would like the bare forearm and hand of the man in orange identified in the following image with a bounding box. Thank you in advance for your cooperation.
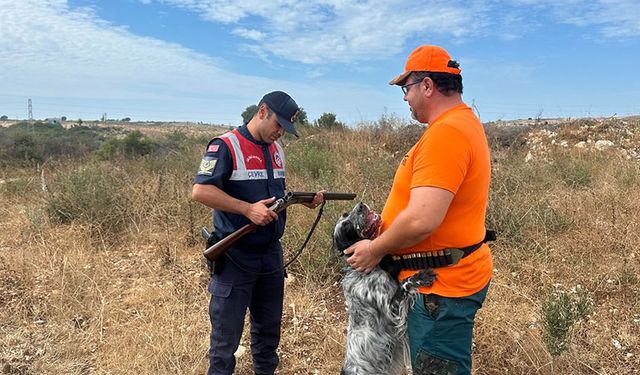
[344,186,454,273]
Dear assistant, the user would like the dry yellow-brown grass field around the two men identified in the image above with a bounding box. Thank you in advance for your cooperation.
[0,119,640,375]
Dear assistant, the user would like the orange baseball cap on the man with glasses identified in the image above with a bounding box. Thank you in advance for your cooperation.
[389,45,461,85]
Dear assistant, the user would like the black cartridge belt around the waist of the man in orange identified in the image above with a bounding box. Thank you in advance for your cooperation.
[392,230,496,270]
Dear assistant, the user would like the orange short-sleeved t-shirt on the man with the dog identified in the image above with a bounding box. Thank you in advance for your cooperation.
[381,104,493,297]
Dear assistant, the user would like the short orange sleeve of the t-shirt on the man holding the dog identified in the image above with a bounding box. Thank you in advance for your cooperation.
[411,124,471,194]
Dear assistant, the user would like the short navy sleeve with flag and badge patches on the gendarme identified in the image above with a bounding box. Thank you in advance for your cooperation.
[193,138,233,189]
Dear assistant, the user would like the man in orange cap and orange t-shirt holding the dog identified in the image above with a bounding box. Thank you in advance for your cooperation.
[345,45,493,375]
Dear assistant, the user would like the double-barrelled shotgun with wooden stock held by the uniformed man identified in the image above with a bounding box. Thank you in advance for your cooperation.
[204,191,356,261]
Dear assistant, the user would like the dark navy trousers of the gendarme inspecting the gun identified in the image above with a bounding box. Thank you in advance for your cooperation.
[208,244,284,375]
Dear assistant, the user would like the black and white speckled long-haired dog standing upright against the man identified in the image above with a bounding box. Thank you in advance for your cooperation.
[333,203,435,375]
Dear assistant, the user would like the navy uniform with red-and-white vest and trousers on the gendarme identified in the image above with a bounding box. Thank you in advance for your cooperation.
[194,125,286,375]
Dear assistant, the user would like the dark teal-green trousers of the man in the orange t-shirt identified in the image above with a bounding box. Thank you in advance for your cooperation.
[407,284,489,375]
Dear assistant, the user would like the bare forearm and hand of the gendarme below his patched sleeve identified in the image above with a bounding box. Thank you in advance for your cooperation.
[191,184,278,225]
